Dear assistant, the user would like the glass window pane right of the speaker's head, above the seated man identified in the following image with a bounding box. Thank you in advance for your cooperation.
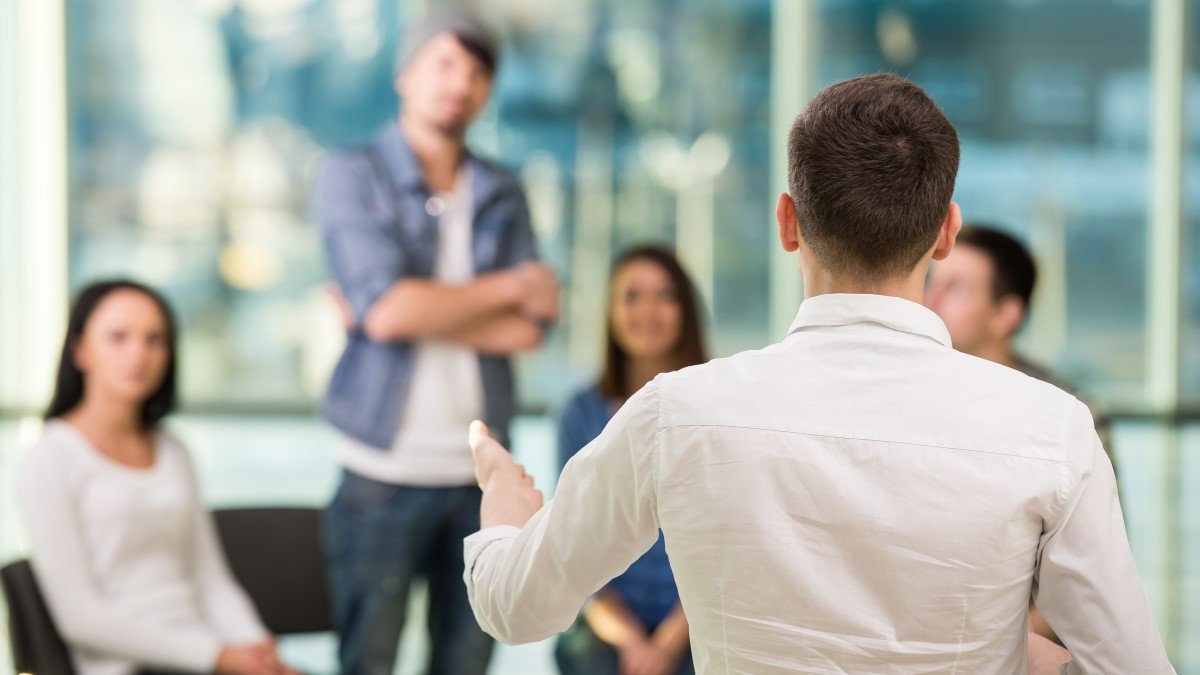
[816,0,1150,406]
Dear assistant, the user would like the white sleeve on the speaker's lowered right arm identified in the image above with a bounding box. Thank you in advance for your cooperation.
[1033,404,1175,674]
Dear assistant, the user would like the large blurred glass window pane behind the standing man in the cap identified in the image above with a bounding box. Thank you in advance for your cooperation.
[68,0,772,408]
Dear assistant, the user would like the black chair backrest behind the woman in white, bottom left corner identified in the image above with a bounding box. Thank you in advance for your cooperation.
[0,560,74,675]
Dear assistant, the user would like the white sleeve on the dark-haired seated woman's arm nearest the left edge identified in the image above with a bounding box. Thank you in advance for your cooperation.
[18,446,222,673]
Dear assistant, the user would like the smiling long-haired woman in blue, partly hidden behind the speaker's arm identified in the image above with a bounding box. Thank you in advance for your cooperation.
[554,246,707,675]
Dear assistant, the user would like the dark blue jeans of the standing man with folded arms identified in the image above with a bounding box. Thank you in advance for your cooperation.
[325,471,492,675]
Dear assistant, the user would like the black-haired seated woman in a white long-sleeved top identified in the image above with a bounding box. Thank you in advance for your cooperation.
[18,281,293,675]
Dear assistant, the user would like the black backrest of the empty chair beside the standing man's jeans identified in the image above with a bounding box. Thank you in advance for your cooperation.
[214,508,334,635]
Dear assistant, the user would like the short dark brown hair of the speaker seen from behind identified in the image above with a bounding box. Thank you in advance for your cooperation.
[787,73,959,281]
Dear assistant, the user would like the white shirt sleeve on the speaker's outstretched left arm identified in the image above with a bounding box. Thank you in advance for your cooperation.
[463,383,659,644]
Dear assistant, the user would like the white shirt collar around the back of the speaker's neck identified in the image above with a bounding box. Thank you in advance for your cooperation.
[787,293,952,347]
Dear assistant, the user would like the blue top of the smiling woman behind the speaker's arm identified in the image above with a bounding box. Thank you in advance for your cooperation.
[558,386,679,631]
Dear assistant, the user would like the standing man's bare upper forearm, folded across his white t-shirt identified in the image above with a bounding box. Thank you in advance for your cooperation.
[362,273,521,342]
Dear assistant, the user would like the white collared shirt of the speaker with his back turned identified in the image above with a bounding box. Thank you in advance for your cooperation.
[464,294,1174,674]
